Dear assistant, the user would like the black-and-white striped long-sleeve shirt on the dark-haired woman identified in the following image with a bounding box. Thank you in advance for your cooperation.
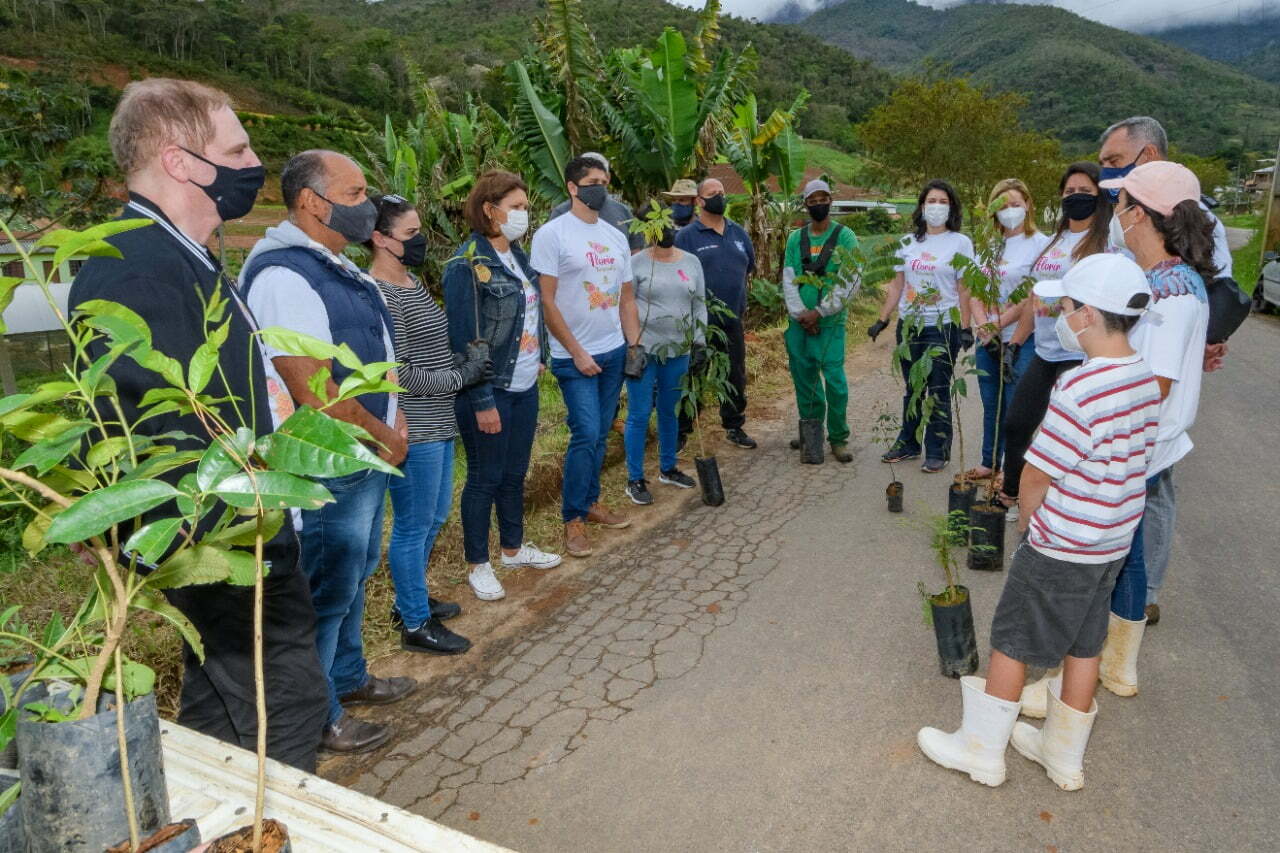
[378,279,462,442]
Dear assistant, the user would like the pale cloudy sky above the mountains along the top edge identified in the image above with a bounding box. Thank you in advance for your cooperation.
[701,0,1280,31]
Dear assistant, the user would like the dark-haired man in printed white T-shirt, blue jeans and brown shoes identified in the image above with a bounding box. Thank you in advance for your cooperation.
[530,156,643,557]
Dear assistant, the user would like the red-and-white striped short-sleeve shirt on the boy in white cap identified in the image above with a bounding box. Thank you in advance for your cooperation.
[1027,355,1160,564]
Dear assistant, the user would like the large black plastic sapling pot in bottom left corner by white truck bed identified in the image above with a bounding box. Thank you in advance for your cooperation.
[18,693,169,853]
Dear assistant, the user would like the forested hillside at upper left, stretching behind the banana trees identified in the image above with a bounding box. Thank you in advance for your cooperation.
[0,0,892,138]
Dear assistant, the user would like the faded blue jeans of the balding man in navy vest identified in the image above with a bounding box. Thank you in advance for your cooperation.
[300,471,388,722]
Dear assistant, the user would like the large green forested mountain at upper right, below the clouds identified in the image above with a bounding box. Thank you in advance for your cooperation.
[800,0,1280,155]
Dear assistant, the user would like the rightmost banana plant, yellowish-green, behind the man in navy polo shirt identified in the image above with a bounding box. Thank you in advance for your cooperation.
[723,91,809,279]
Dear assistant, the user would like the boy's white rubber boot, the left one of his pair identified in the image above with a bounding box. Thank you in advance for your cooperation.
[915,675,1018,788]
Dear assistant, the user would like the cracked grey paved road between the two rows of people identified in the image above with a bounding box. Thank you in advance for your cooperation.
[356,318,1280,852]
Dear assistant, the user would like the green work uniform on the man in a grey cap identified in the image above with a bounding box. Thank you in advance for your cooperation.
[783,219,858,444]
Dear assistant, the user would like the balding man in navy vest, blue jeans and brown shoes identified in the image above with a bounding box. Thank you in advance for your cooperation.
[241,151,417,753]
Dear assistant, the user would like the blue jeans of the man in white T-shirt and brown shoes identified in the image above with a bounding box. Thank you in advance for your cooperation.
[552,346,627,523]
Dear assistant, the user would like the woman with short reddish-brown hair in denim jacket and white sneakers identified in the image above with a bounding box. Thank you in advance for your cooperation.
[444,172,561,601]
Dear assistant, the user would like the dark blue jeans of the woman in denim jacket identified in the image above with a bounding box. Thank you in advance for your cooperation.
[453,384,538,565]
